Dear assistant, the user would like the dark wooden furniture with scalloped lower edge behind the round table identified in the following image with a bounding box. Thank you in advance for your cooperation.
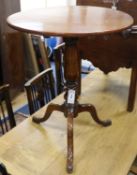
[77,0,137,111]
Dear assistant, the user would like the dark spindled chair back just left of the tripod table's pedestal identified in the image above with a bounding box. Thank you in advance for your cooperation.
[25,68,55,114]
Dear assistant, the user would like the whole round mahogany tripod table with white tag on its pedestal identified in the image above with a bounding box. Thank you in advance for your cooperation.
[8,6,133,173]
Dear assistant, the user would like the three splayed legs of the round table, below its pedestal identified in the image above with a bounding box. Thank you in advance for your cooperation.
[32,102,111,173]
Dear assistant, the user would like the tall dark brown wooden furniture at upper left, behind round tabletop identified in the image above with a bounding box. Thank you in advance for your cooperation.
[0,0,25,92]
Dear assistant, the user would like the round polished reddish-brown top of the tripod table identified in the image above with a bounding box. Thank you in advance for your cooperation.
[7,6,133,37]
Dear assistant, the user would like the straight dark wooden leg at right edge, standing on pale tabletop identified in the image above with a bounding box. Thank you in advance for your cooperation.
[127,68,137,112]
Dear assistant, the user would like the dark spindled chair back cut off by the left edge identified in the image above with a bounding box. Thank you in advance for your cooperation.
[0,85,16,134]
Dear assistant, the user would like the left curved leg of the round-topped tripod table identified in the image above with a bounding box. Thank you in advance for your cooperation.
[32,103,64,123]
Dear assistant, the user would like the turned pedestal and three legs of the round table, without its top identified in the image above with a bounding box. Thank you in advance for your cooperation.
[33,38,111,173]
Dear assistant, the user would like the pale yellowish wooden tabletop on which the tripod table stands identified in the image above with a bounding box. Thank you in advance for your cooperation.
[0,70,137,175]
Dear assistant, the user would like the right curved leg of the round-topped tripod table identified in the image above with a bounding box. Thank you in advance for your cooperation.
[78,104,112,126]
